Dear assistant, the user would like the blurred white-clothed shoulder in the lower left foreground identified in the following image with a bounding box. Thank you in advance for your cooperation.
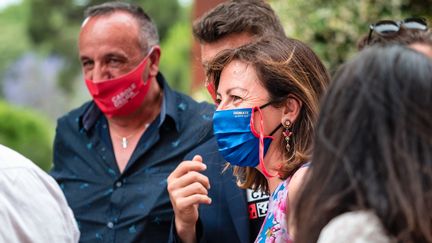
[0,145,80,242]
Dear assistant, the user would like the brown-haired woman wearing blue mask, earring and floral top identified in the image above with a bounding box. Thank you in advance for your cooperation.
[207,37,329,242]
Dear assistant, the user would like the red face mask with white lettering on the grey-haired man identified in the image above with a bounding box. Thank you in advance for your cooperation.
[85,49,158,117]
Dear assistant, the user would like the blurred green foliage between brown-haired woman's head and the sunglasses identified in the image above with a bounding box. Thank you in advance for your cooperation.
[271,0,432,73]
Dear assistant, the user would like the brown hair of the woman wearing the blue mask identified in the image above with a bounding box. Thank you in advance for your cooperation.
[206,36,329,192]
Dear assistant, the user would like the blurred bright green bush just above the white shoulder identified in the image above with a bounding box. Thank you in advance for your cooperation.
[0,101,53,171]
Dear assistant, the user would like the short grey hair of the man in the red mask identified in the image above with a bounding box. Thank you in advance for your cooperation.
[84,2,159,52]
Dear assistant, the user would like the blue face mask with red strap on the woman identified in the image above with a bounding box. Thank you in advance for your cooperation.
[213,103,281,177]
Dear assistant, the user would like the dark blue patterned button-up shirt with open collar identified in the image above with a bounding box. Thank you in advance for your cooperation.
[51,74,214,243]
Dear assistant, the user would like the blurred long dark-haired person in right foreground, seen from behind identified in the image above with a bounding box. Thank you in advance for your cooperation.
[294,46,432,243]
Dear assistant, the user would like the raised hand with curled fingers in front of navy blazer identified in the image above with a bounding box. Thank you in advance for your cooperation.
[167,155,211,242]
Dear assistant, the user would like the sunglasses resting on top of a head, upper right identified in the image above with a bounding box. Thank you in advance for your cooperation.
[367,18,428,44]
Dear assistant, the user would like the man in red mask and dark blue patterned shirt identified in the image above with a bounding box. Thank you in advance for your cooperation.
[51,2,214,243]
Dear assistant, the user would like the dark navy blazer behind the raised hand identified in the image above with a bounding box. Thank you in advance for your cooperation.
[169,138,250,243]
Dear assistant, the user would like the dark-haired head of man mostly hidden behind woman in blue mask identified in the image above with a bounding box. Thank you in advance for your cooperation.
[192,0,285,99]
